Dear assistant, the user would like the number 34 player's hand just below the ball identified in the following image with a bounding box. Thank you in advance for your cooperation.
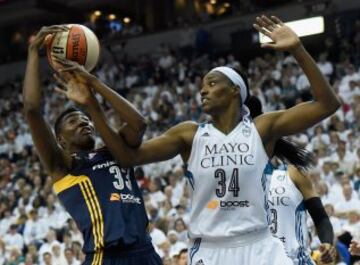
[54,72,94,105]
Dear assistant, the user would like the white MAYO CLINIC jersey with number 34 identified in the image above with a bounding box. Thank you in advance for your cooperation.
[186,121,272,240]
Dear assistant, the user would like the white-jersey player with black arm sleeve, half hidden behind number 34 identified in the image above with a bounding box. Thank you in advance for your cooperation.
[268,164,336,265]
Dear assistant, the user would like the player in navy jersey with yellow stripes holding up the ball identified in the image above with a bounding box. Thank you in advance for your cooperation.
[23,26,162,265]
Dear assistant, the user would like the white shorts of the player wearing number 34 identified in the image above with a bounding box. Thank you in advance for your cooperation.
[188,229,294,265]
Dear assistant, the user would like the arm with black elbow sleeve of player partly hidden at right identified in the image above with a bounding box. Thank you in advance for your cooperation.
[289,166,336,264]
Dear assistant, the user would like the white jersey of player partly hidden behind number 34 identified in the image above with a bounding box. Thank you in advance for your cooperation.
[268,166,313,264]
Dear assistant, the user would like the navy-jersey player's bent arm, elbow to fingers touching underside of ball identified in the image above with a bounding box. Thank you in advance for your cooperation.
[56,58,146,147]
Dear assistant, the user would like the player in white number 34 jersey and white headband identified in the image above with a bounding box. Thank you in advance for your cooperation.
[57,16,340,265]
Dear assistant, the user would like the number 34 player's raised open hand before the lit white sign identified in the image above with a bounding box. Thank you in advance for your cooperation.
[253,15,301,52]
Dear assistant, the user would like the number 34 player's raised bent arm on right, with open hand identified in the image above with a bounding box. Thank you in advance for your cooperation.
[254,16,340,139]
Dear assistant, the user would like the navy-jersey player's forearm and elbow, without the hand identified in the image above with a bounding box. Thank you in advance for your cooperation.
[91,78,146,147]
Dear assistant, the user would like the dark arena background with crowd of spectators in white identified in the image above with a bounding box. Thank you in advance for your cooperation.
[0,0,360,265]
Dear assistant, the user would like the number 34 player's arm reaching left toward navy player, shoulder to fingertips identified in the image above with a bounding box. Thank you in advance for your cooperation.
[57,72,197,167]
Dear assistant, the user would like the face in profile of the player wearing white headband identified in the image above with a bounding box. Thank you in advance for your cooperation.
[200,71,240,115]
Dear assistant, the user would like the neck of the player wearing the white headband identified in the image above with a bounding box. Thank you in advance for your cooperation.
[212,106,241,134]
